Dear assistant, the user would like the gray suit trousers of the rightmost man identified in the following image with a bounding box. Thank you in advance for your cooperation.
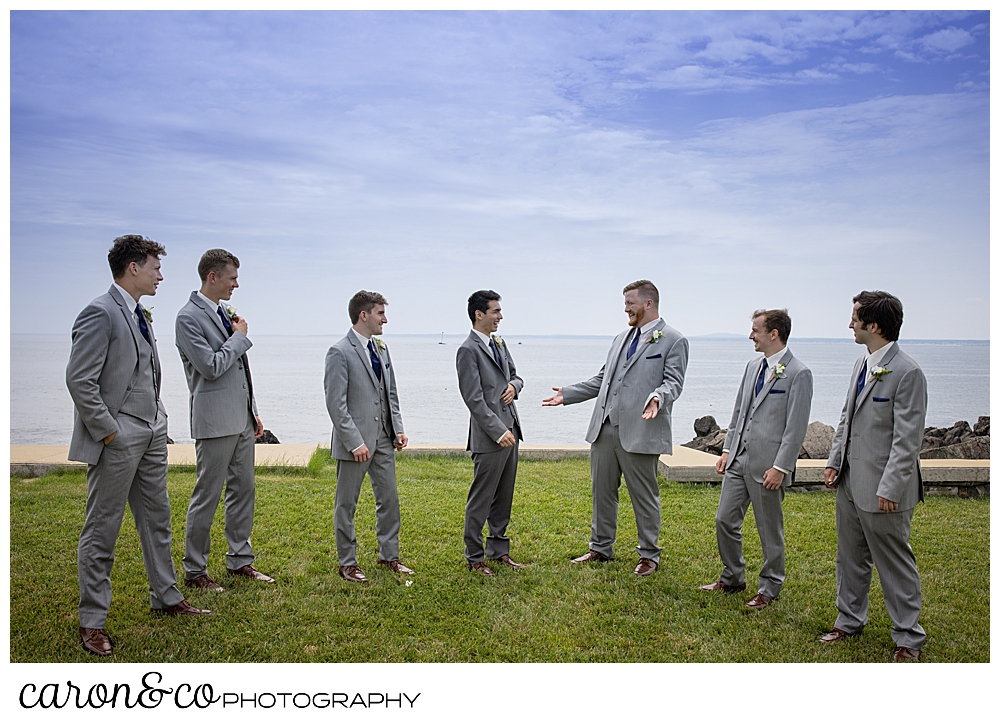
[835,476,927,650]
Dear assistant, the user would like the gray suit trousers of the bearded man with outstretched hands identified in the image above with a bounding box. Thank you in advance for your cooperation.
[590,421,662,563]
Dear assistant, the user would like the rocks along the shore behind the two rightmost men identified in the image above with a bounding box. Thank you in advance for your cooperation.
[681,415,990,459]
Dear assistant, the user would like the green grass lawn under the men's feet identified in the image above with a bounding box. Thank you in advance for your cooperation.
[10,454,990,662]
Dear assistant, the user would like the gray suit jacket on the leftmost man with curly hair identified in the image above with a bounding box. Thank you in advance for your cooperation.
[66,285,166,464]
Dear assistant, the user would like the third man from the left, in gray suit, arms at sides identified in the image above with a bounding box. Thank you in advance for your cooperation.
[323,291,413,583]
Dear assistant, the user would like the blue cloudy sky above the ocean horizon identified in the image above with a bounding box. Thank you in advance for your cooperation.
[10,12,989,339]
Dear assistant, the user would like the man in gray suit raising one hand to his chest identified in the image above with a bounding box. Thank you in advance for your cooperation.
[174,249,274,592]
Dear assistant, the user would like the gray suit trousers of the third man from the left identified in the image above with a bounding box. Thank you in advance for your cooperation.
[334,428,399,567]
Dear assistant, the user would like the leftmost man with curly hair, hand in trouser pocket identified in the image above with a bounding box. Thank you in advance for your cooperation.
[66,235,210,655]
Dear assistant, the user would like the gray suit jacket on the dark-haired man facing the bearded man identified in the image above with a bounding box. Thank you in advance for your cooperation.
[455,331,524,452]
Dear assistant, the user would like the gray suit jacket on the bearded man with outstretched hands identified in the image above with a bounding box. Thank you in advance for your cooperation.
[563,319,688,454]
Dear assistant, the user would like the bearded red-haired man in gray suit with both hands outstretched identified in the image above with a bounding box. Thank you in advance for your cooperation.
[542,279,688,576]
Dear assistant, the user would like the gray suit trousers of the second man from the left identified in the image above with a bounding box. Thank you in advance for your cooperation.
[184,413,257,580]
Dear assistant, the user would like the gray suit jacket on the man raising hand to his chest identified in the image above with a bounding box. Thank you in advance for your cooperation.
[174,291,257,439]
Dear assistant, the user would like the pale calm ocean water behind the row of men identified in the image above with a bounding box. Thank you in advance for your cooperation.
[10,334,990,444]
